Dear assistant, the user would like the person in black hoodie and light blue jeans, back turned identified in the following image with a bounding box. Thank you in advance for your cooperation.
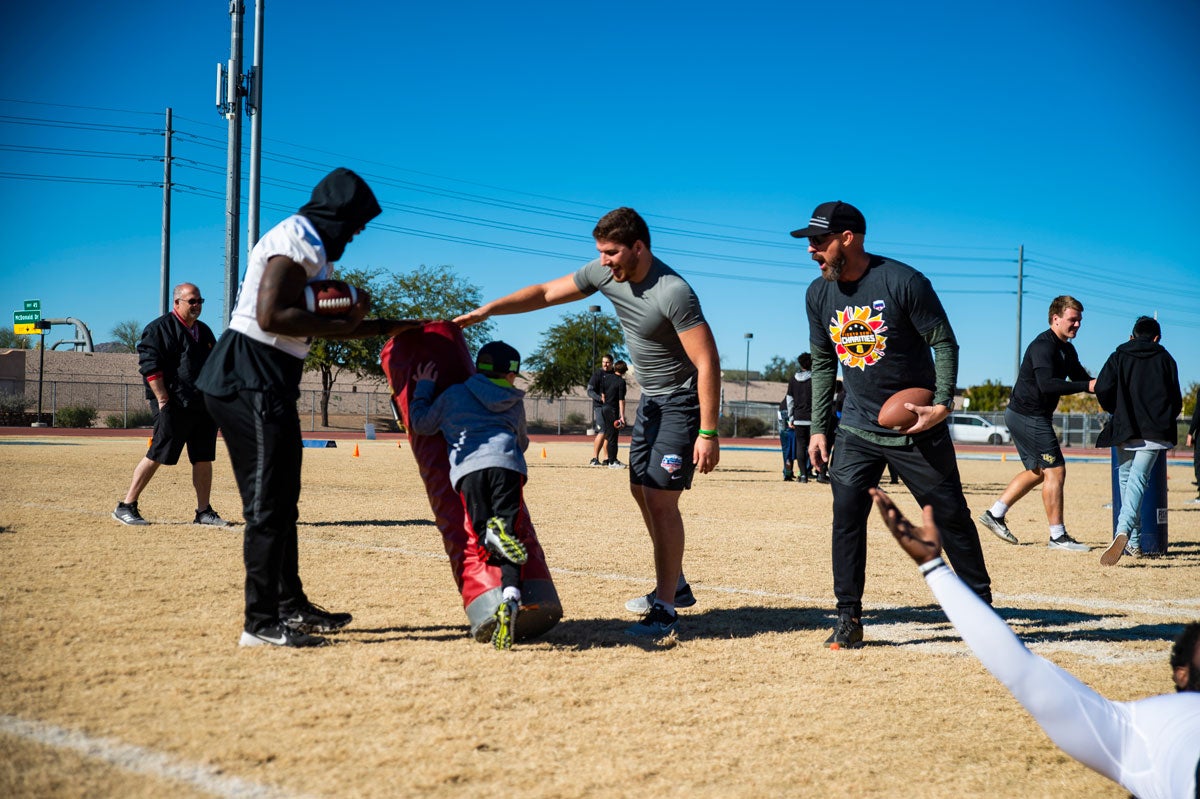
[1096,317,1183,566]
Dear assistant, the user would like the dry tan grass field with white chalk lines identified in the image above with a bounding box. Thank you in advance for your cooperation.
[0,437,1200,798]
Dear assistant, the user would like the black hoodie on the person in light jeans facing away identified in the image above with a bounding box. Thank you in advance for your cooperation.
[1096,338,1183,446]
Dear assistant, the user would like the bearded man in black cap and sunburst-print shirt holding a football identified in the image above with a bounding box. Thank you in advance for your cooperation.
[792,202,991,649]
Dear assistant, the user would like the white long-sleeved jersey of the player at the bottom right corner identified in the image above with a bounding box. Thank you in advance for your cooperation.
[926,567,1200,799]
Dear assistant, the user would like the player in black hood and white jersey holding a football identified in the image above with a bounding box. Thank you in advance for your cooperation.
[197,168,420,647]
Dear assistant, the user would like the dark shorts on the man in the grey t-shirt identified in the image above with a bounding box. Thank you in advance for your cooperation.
[629,391,700,491]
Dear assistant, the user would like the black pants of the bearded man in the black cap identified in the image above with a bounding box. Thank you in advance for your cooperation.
[829,425,991,618]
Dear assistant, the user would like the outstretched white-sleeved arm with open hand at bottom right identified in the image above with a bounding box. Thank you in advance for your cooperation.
[871,488,1136,789]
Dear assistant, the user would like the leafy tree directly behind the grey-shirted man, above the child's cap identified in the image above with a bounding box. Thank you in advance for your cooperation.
[525,311,629,398]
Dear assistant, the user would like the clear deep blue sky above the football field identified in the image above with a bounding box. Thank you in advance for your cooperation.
[0,0,1200,386]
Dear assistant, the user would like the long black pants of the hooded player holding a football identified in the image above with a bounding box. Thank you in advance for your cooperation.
[205,390,307,632]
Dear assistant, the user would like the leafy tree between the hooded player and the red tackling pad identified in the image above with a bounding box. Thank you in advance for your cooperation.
[304,265,491,427]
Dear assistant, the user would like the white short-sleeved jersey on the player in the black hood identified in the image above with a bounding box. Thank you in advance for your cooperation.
[229,214,332,360]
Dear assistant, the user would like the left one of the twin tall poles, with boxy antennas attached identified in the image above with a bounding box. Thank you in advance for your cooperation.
[217,0,246,326]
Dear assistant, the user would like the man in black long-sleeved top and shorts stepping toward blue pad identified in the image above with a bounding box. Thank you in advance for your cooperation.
[979,294,1096,552]
